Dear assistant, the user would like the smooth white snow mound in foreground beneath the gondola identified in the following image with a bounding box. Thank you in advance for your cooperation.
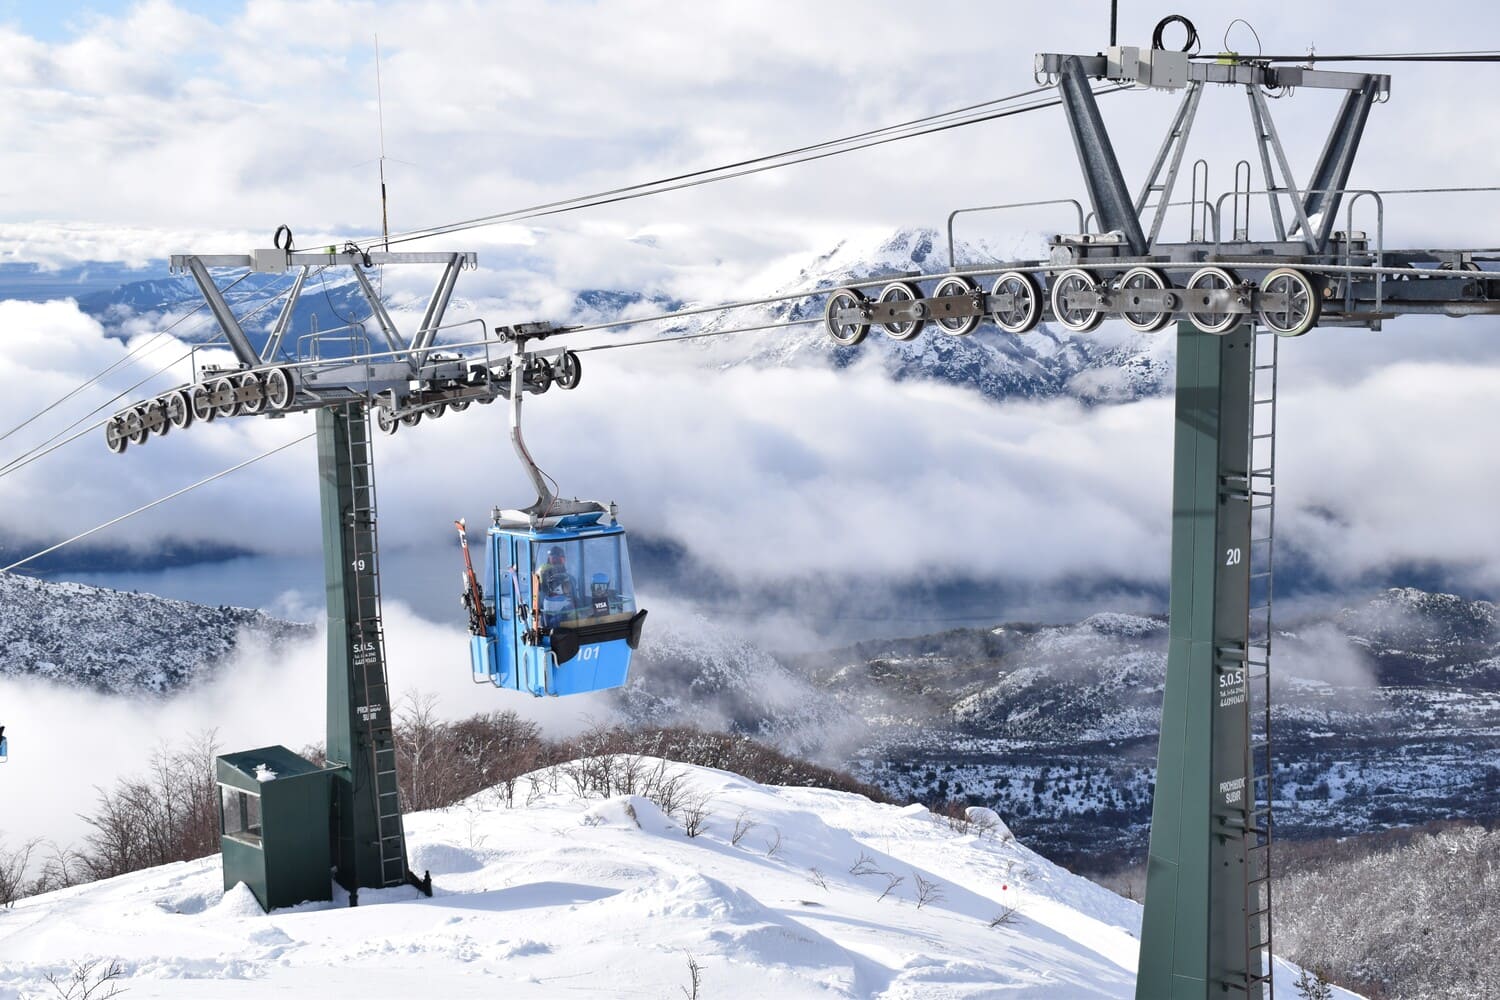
[0,762,1353,1000]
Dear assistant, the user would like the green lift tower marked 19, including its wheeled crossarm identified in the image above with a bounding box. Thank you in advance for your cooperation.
[105,245,578,906]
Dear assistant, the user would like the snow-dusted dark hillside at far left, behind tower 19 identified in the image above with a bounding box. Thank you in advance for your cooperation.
[0,573,312,694]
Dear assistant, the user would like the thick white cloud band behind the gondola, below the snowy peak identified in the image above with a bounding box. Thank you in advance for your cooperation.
[0,293,1500,599]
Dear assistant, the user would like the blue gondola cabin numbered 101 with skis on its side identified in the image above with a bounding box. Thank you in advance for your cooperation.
[459,502,647,697]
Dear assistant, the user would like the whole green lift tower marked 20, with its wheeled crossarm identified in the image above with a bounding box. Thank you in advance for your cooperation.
[825,27,1500,1000]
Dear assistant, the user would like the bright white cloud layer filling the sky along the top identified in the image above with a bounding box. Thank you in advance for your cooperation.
[0,0,1500,269]
